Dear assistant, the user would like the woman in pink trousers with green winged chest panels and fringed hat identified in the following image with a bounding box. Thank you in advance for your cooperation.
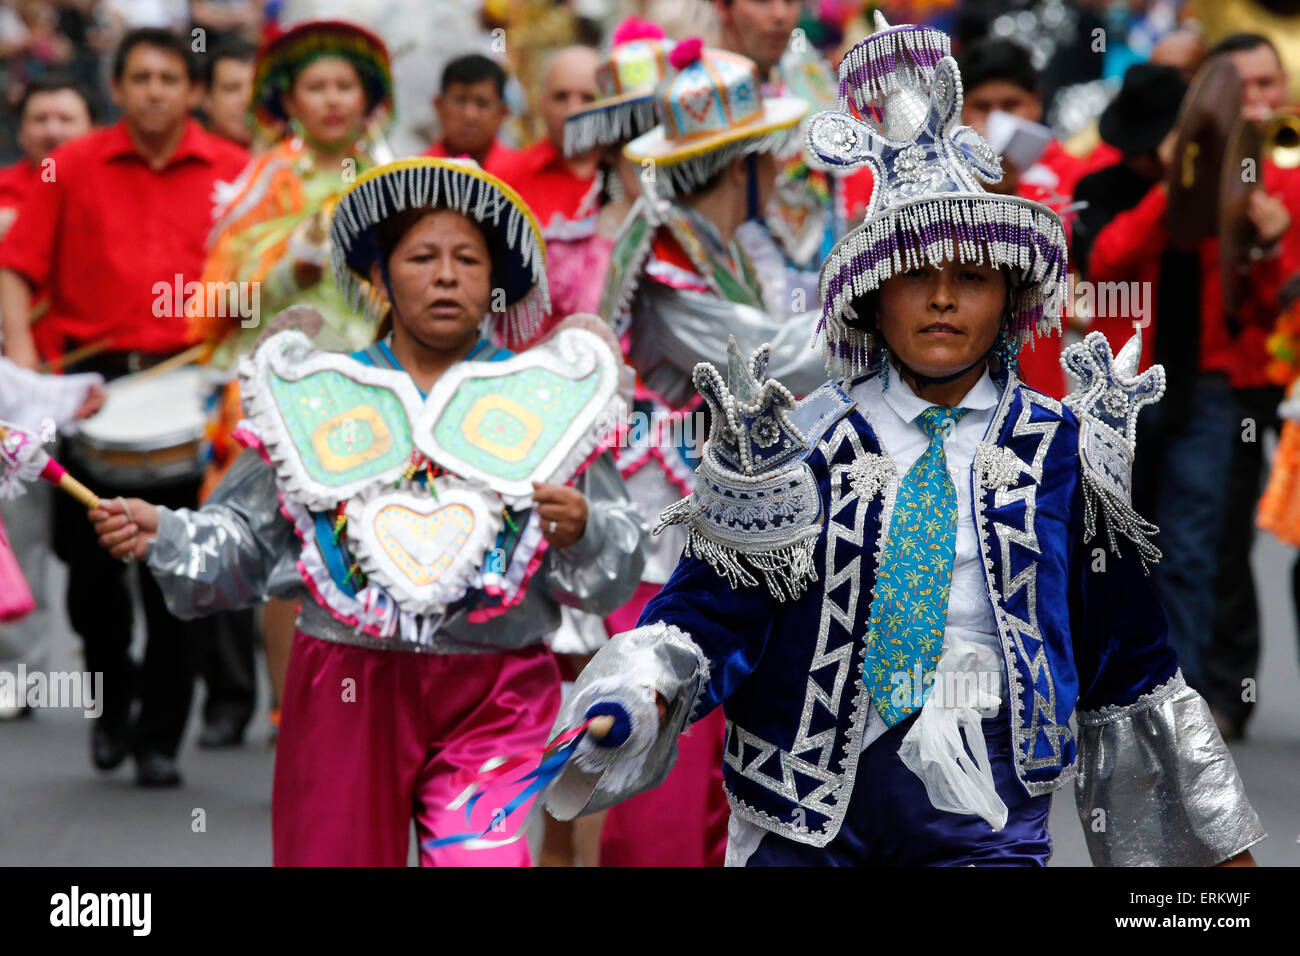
[91,159,645,865]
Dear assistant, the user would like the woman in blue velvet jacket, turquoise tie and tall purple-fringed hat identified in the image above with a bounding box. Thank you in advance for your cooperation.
[547,13,1264,866]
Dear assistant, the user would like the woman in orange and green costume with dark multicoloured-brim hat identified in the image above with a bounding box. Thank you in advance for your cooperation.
[191,21,393,726]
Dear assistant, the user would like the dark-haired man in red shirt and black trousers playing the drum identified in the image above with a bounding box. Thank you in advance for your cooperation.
[0,29,247,786]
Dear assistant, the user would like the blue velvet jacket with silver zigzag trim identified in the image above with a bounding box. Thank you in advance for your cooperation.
[641,378,1178,845]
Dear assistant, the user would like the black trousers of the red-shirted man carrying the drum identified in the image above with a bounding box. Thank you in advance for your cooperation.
[55,473,212,756]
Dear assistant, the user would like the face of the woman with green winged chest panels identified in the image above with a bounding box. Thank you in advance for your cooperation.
[371,209,491,351]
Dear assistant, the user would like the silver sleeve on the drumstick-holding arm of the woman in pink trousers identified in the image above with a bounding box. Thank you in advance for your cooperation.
[147,450,298,619]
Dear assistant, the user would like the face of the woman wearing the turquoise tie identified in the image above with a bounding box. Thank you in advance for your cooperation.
[878,261,1008,378]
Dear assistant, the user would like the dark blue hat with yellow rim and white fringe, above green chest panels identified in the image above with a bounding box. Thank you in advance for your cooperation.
[329,156,551,342]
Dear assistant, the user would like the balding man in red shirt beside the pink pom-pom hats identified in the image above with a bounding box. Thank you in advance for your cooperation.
[499,47,601,235]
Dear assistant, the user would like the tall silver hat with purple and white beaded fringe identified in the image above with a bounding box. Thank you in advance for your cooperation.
[807,13,1066,377]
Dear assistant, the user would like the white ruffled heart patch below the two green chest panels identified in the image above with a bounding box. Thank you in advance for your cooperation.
[347,479,502,614]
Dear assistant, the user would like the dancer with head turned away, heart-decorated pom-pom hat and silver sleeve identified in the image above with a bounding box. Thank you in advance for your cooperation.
[599,39,824,866]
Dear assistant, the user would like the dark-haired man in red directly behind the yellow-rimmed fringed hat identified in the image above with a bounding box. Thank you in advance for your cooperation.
[424,53,519,176]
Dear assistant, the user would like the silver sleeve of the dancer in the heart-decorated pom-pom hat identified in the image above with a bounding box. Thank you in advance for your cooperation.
[628,282,826,407]
